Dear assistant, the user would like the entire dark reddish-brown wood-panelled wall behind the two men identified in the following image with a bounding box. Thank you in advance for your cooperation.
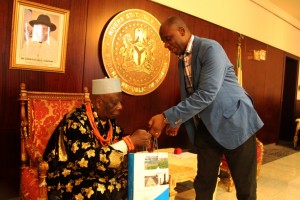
[0,0,296,199]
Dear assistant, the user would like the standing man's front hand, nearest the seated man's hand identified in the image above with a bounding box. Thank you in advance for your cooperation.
[148,114,166,138]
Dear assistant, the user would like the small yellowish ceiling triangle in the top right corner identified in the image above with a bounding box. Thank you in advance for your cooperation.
[269,0,300,23]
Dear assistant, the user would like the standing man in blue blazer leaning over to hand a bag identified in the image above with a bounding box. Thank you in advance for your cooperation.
[149,17,263,200]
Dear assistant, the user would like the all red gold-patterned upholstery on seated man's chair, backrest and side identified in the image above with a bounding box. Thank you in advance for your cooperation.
[21,99,83,200]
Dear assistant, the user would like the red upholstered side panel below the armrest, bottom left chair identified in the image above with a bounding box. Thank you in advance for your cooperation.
[21,167,39,200]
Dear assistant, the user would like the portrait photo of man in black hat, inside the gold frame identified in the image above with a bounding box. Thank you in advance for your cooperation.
[20,10,59,65]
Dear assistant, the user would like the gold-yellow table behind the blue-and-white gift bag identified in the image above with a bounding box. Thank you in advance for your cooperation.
[155,148,219,200]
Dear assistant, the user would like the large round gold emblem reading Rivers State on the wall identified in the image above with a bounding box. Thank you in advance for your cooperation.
[102,9,170,95]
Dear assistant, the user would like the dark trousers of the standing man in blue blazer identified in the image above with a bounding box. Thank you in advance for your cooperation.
[194,122,257,200]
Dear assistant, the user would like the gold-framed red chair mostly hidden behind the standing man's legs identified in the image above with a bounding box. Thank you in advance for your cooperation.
[220,138,264,192]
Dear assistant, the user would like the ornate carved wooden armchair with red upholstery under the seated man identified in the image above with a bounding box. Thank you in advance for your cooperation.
[19,83,90,200]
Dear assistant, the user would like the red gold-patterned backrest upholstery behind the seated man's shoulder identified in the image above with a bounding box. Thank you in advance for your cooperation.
[29,99,83,154]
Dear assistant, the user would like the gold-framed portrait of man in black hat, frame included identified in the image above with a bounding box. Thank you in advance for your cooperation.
[9,0,70,73]
